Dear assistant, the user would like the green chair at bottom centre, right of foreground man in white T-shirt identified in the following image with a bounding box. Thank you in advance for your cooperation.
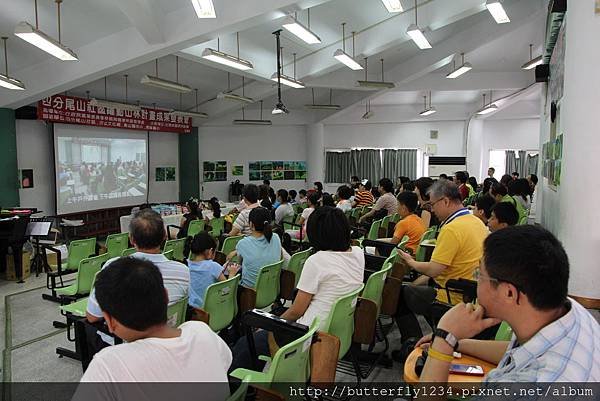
[231,317,319,386]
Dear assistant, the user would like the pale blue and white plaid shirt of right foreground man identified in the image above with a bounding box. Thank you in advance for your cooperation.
[484,298,600,387]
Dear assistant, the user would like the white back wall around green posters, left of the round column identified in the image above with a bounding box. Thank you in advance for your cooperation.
[198,125,311,201]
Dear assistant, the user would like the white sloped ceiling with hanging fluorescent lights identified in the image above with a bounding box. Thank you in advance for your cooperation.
[0,0,547,124]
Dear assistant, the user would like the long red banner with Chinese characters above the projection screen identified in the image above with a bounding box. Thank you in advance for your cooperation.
[37,95,192,134]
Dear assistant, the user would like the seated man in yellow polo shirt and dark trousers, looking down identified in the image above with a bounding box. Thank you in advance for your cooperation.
[392,180,488,356]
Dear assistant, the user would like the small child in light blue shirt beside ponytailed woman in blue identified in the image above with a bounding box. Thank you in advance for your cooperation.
[184,232,237,308]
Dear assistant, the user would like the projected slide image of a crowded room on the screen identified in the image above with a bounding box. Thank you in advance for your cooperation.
[56,137,148,209]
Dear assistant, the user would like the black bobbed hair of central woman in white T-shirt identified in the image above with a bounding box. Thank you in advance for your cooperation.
[306,206,350,252]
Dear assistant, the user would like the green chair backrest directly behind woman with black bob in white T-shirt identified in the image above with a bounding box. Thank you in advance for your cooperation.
[323,284,364,359]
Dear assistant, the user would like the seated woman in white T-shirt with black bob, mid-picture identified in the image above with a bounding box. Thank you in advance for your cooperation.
[230,207,365,370]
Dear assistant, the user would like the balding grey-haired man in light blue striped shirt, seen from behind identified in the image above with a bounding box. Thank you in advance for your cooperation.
[86,209,190,323]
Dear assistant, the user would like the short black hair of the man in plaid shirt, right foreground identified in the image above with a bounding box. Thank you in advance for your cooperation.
[483,225,569,310]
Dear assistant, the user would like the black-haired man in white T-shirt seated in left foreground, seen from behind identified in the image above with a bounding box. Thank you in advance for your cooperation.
[81,257,232,390]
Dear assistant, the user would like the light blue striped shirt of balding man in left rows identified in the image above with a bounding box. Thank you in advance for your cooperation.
[87,252,190,317]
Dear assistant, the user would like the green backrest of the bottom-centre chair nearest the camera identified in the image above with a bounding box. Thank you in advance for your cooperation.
[267,317,319,383]
